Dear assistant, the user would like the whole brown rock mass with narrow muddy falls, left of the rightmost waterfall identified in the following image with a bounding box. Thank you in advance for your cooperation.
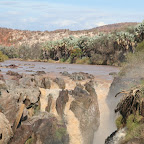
[0,71,100,144]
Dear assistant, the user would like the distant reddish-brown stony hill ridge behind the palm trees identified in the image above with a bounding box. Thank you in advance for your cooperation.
[0,22,138,46]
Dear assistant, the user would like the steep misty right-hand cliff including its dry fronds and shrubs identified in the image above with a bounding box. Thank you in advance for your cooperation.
[106,45,144,144]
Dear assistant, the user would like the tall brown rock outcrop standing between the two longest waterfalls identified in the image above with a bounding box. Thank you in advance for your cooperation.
[70,82,100,144]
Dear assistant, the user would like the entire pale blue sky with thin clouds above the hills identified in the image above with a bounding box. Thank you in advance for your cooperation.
[0,0,144,31]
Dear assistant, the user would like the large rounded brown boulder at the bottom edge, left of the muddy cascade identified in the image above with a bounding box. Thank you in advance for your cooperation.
[9,112,69,144]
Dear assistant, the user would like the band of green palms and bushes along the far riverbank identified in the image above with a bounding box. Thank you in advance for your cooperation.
[0,22,144,65]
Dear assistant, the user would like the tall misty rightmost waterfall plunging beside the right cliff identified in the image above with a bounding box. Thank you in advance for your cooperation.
[93,81,116,144]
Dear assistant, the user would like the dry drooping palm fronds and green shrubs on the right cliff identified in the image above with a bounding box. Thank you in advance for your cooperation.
[115,81,144,144]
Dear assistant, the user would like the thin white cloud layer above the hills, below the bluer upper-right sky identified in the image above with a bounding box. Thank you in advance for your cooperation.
[0,0,143,31]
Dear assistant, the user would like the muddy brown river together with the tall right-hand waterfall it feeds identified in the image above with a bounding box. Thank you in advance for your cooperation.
[0,60,119,144]
